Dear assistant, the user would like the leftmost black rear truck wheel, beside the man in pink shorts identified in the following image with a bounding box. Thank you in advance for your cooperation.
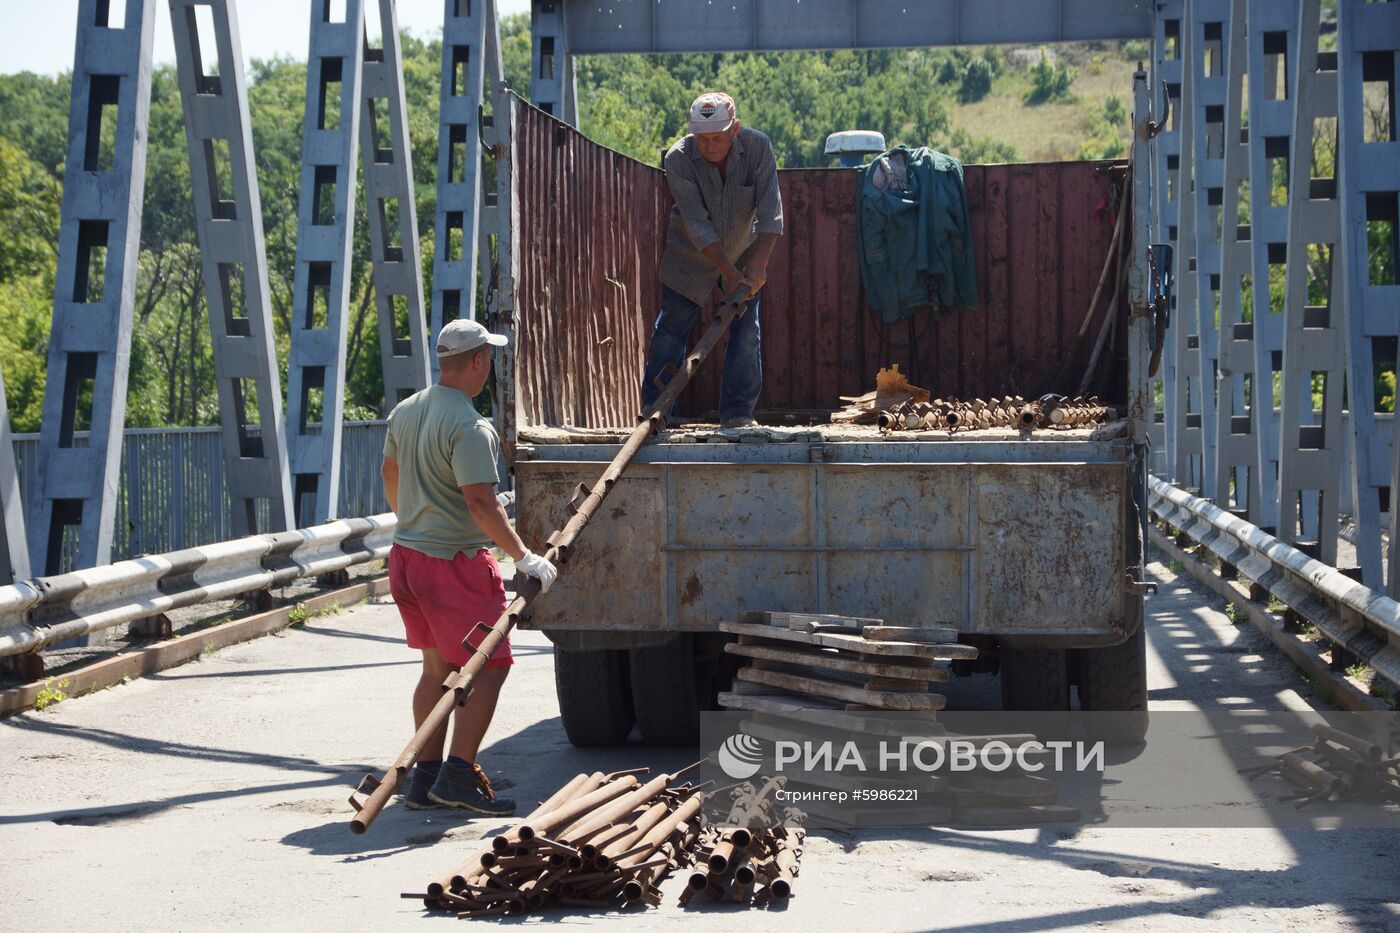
[554,649,633,748]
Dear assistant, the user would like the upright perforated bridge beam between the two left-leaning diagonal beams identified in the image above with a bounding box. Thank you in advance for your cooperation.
[287,0,364,527]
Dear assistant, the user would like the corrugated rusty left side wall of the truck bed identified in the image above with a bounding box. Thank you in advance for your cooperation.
[511,98,671,427]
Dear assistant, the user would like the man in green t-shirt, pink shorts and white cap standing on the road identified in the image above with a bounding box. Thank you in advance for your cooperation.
[382,321,556,817]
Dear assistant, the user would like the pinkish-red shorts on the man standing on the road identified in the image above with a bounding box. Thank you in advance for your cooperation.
[389,545,515,667]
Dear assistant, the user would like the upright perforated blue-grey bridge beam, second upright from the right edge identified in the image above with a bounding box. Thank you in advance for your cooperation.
[1246,0,1298,530]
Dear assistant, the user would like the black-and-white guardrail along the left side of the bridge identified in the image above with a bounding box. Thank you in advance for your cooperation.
[0,513,396,657]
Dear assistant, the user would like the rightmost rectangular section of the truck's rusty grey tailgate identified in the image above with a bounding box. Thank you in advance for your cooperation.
[976,464,1128,635]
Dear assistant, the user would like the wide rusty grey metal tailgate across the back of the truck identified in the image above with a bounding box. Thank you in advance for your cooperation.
[517,461,1127,636]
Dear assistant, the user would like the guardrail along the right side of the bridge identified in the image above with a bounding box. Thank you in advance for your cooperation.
[1148,476,1400,685]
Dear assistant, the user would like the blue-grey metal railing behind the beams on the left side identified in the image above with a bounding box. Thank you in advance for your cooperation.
[14,420,389,569]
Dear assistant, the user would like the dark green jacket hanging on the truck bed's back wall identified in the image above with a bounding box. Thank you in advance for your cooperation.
[855,146,977,321]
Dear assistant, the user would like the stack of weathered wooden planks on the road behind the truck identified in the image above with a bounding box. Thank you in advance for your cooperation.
[720,612,1079,827]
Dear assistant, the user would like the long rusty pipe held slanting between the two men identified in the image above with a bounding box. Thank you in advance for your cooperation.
[350,286,748,834]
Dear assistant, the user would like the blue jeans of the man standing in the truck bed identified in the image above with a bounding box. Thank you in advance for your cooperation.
[641,286,763,420]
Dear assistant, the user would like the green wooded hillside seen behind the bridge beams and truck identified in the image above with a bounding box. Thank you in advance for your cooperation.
[0,22,1126,431]
